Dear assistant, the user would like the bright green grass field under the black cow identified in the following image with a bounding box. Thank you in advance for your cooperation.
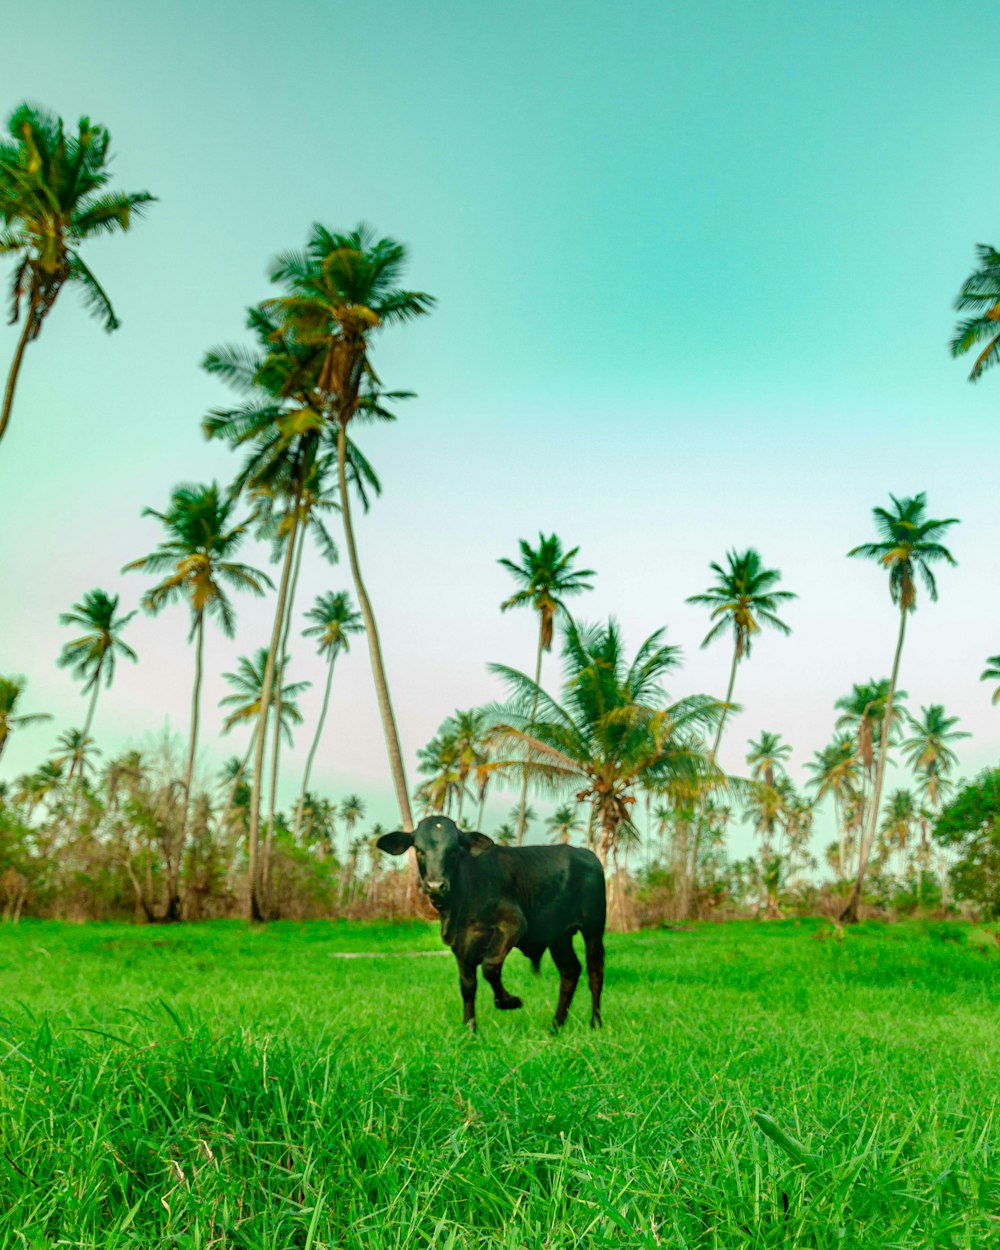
[0,921,1000,1250]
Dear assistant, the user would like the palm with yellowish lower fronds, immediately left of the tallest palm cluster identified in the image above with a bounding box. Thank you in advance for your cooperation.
[124,483,271,920]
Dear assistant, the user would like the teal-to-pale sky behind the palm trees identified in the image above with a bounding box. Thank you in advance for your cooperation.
[0,0,1000,850]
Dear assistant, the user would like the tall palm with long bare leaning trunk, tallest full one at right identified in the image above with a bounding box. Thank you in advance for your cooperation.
[841,491,958,923]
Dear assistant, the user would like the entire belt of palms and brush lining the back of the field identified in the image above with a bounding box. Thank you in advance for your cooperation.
[0,105,1000,925]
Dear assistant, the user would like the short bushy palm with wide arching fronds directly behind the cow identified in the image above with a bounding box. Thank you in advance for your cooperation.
[490,620,724,865]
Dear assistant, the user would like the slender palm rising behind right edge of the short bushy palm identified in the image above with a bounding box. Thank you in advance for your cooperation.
[688,548,796,764]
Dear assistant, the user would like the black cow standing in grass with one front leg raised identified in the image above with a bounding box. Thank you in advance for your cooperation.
[379,816,606,1030]
